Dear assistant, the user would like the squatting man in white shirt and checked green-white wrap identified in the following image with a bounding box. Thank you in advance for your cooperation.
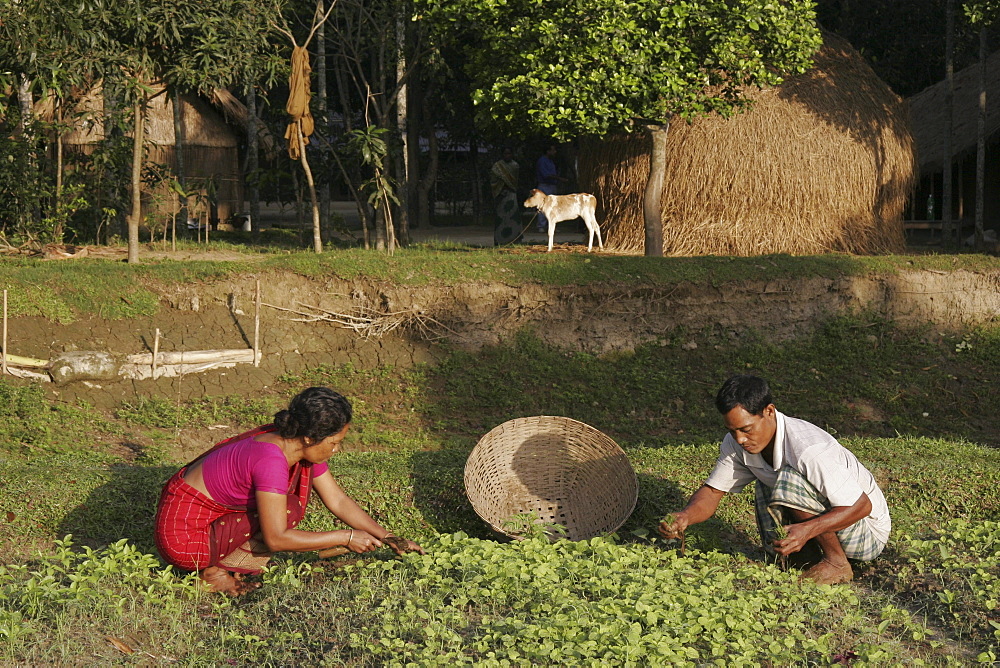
[658,376,892,584]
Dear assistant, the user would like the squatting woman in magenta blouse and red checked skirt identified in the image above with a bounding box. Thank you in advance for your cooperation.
[156,387,423,596]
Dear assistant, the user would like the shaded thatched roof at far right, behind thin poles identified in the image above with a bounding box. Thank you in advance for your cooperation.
[908,52,1000,172]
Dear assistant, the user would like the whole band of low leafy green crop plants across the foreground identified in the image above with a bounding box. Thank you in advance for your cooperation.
[0,533,968,666]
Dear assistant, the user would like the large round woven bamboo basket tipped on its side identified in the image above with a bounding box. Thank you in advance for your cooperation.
[465,415,639,540]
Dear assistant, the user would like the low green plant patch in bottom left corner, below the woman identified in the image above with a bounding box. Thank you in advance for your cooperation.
[0,536,230,665]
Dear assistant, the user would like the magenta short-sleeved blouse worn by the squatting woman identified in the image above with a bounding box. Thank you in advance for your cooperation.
[201,436,329,508]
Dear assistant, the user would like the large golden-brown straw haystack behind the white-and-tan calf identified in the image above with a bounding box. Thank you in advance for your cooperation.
[579,34,916,255]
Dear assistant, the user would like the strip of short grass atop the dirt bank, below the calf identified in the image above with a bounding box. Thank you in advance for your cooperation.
[0,243,1000,323]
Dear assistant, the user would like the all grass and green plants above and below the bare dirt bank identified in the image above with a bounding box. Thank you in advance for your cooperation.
[0,249,1000,666]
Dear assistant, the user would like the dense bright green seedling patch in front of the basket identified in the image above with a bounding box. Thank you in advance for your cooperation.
[337,534,920,666]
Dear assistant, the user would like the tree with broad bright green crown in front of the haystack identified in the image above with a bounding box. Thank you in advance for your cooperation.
[422,0,821,255]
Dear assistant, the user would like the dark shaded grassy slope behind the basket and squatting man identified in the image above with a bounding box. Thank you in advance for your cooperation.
[428,315,1000,446]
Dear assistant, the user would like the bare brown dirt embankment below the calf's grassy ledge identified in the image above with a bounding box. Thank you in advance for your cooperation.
[9,270,1000,406]
